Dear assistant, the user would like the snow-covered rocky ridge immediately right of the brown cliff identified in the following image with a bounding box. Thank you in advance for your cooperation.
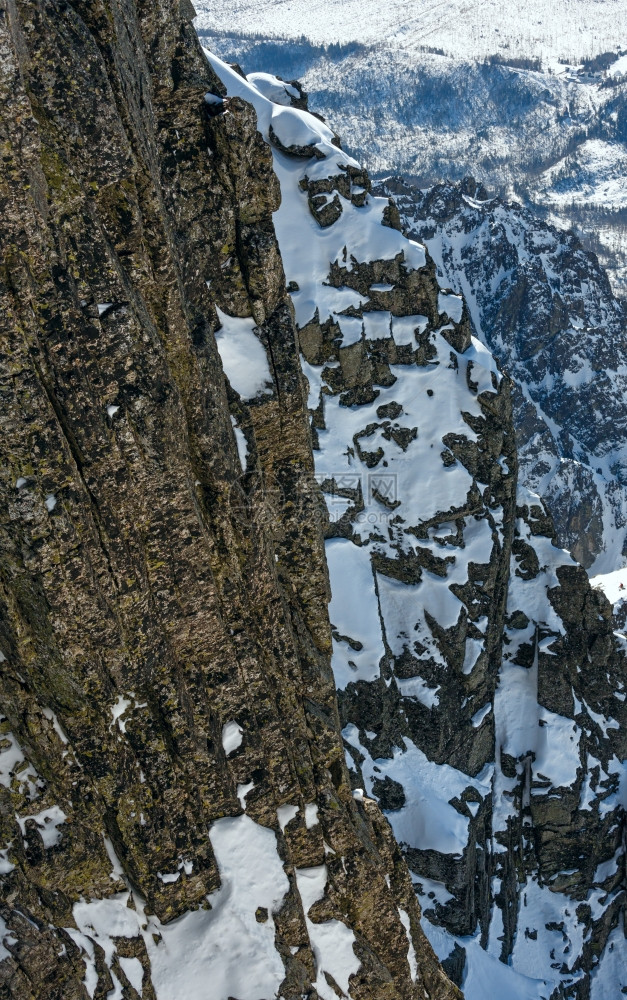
[209,54,627,1000]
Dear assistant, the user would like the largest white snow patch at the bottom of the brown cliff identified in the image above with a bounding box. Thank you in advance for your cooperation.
[73,815,289,1000]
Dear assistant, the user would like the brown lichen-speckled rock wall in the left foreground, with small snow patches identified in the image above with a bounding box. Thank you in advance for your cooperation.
[0,0,458,1000]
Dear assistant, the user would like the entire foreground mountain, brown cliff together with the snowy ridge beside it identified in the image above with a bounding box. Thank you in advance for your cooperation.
[0,0,626,1000]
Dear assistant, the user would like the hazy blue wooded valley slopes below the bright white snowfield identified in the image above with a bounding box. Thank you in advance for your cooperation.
[201,35,627,295]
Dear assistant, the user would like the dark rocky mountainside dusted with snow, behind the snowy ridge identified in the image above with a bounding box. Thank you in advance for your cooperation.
[381,179,627,572]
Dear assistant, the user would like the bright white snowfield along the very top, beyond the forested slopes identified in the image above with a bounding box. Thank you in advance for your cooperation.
[195,0,627,58]
